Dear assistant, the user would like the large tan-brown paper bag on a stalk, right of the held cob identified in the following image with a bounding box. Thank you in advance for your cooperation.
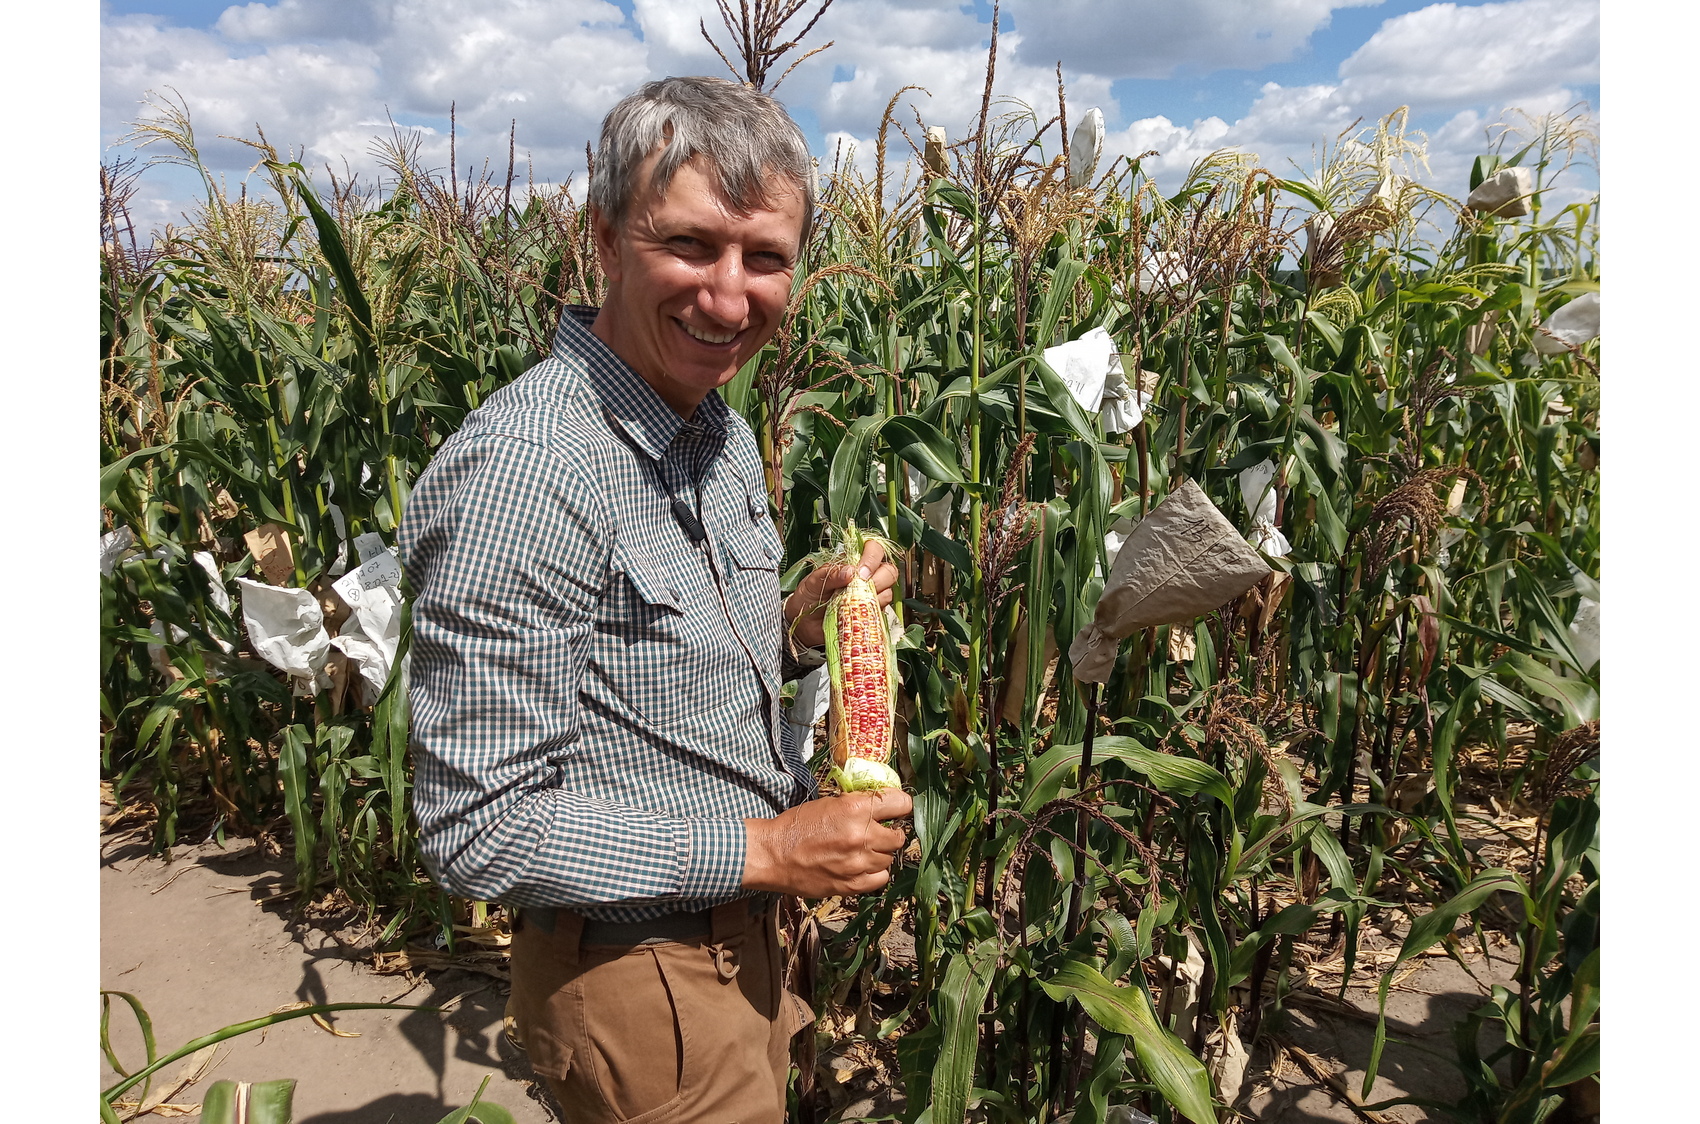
[1068,480,1270,684]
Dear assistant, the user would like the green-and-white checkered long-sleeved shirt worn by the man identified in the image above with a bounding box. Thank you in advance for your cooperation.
[400,308,814,922]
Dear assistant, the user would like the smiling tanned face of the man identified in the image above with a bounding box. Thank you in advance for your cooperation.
[592,153,802,418]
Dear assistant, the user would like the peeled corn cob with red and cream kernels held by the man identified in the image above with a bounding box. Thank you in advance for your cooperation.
[823,522,903,792]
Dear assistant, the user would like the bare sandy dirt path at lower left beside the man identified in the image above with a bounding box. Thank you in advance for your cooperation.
[100,842,556,1124]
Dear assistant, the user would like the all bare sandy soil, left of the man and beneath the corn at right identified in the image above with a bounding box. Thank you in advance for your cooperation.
[100,819,1515,1124]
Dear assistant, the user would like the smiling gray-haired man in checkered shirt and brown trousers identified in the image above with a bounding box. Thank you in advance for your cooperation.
[400,78,910,1124]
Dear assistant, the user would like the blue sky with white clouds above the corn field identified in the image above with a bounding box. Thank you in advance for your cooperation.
[100,0,1600,228]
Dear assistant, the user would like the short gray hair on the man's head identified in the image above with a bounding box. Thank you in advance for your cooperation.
[590,78,814,248]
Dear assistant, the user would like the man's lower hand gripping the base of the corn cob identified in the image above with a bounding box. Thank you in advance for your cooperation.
[743,789,915,898]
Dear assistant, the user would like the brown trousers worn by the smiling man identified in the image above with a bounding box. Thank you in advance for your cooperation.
[508,901,814,1124]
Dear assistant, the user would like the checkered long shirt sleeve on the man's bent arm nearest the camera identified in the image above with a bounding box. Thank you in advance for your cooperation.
[400,435,745,906]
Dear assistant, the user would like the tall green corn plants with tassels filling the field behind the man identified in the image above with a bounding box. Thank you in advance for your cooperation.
[100,94,1600,1124]
